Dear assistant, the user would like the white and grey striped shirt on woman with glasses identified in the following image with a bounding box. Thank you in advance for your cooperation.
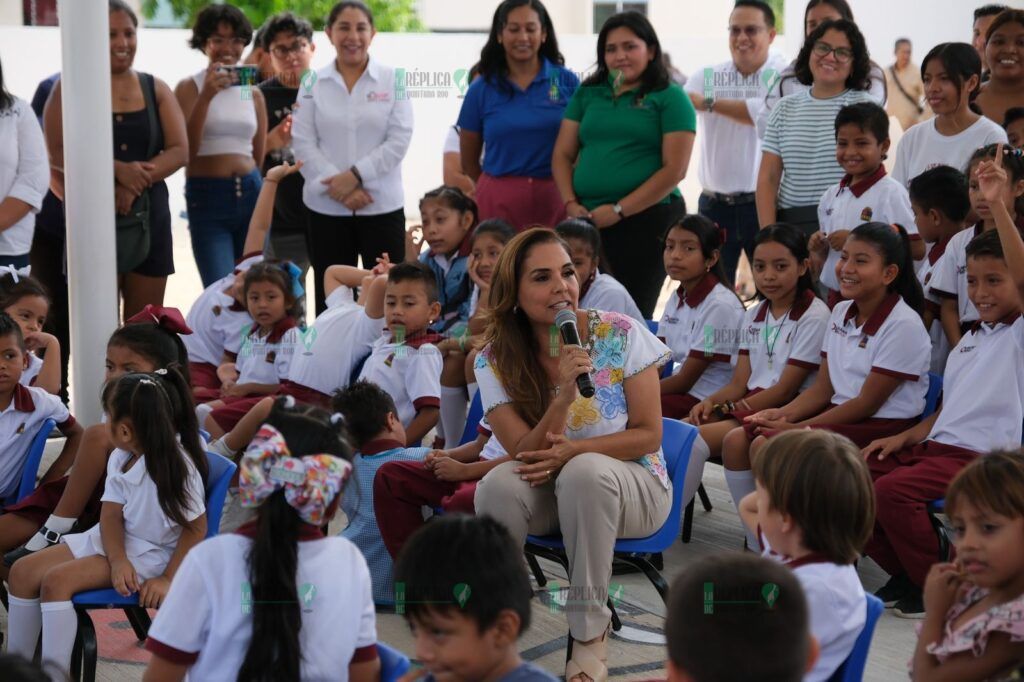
[763,89,872,209]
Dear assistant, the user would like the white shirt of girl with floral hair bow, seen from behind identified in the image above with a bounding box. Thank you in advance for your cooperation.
[146,532,377,682]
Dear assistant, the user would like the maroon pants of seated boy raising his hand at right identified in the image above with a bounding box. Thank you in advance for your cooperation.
[864,440,978,587]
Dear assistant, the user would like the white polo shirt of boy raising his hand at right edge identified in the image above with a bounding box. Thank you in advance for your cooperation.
[928,312,1024,453]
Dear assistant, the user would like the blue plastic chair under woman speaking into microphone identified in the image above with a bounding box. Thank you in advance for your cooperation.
[525,418,697,630]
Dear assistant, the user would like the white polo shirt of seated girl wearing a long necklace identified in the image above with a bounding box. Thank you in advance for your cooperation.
[739,291,831,391]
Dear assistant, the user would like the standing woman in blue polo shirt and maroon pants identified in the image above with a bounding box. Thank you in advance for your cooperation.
[459,0,580,229]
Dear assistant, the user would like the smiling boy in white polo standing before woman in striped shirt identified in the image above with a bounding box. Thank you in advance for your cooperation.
[810,101,925,308]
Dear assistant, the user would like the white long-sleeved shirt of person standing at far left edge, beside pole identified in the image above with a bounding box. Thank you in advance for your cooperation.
[0,97,50,256]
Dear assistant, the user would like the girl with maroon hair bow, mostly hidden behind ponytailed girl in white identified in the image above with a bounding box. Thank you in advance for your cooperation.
[0,305,194,561]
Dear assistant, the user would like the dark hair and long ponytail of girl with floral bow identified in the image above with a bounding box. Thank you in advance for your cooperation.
[238,398,352,682]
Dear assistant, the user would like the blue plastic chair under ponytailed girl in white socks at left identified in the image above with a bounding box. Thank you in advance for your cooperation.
[71,453,238,682]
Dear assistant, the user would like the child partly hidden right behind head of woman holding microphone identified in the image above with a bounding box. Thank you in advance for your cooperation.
[555,218,644,323]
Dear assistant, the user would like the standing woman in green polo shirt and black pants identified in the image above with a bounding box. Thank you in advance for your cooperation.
[551,12,696,318]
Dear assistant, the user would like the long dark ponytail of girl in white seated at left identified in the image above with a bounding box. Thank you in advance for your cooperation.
[103,368,208,525]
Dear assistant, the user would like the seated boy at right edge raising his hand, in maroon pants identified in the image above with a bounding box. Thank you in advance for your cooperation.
[864,143,1024,617]
